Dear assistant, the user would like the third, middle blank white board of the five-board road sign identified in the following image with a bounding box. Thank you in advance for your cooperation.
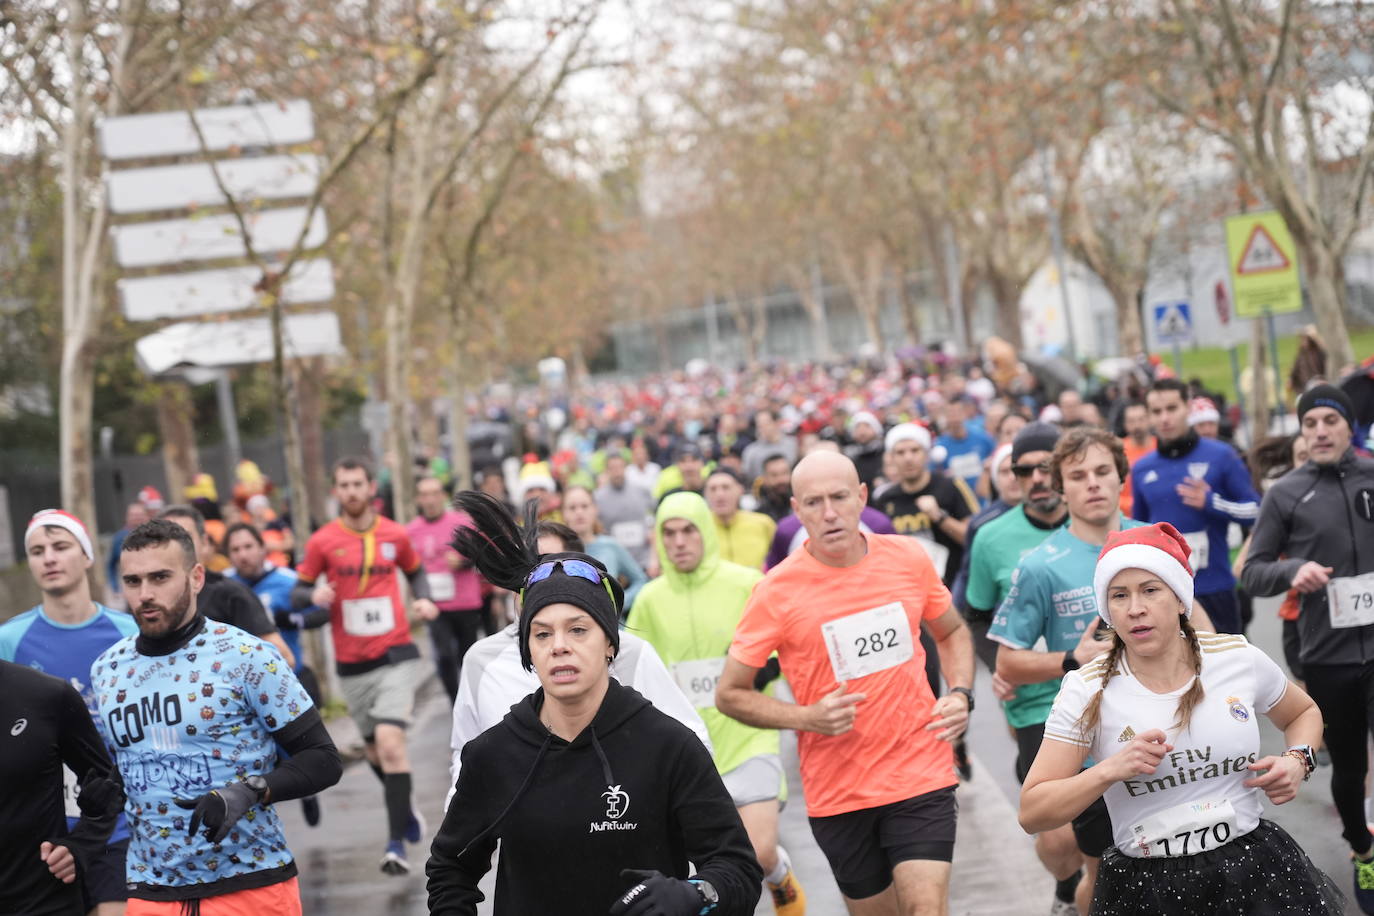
[111,207,328,268]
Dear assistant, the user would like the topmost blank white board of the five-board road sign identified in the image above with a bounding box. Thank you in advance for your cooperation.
[100,99,315,161]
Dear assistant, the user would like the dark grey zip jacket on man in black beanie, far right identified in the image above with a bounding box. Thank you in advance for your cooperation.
[1241,449,1374,665]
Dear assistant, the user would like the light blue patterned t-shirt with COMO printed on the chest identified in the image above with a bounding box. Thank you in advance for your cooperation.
[91,621,311,887]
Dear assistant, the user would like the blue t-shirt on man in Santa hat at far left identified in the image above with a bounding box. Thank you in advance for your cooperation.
[0,604,139,843]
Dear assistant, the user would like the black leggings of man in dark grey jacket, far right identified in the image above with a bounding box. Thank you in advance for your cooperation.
[1303,662,1374,856]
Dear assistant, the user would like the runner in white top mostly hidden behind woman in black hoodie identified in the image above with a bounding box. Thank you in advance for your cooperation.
[444,513,712,810]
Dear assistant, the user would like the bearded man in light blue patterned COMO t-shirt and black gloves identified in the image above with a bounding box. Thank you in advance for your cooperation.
[91,519,344,916]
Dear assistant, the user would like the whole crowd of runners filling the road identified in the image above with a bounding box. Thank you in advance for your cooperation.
[0,346,1374,916]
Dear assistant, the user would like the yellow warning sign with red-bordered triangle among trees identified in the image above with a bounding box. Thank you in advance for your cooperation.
[1226,210,1303,319]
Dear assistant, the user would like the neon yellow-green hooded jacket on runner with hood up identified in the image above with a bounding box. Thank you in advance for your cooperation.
[628,493,779,773]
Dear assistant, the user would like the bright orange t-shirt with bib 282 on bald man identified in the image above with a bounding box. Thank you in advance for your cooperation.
[730,534,958,817]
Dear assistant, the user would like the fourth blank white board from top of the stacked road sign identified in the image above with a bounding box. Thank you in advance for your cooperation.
[115,258,334,321]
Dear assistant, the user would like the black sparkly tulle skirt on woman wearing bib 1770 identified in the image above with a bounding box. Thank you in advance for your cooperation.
[1091,820,1345,916]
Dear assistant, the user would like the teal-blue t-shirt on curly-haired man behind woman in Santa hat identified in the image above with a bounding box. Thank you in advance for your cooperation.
[988,518,1143,722]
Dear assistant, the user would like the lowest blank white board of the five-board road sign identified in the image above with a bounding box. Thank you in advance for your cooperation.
[135,312,344,375]
